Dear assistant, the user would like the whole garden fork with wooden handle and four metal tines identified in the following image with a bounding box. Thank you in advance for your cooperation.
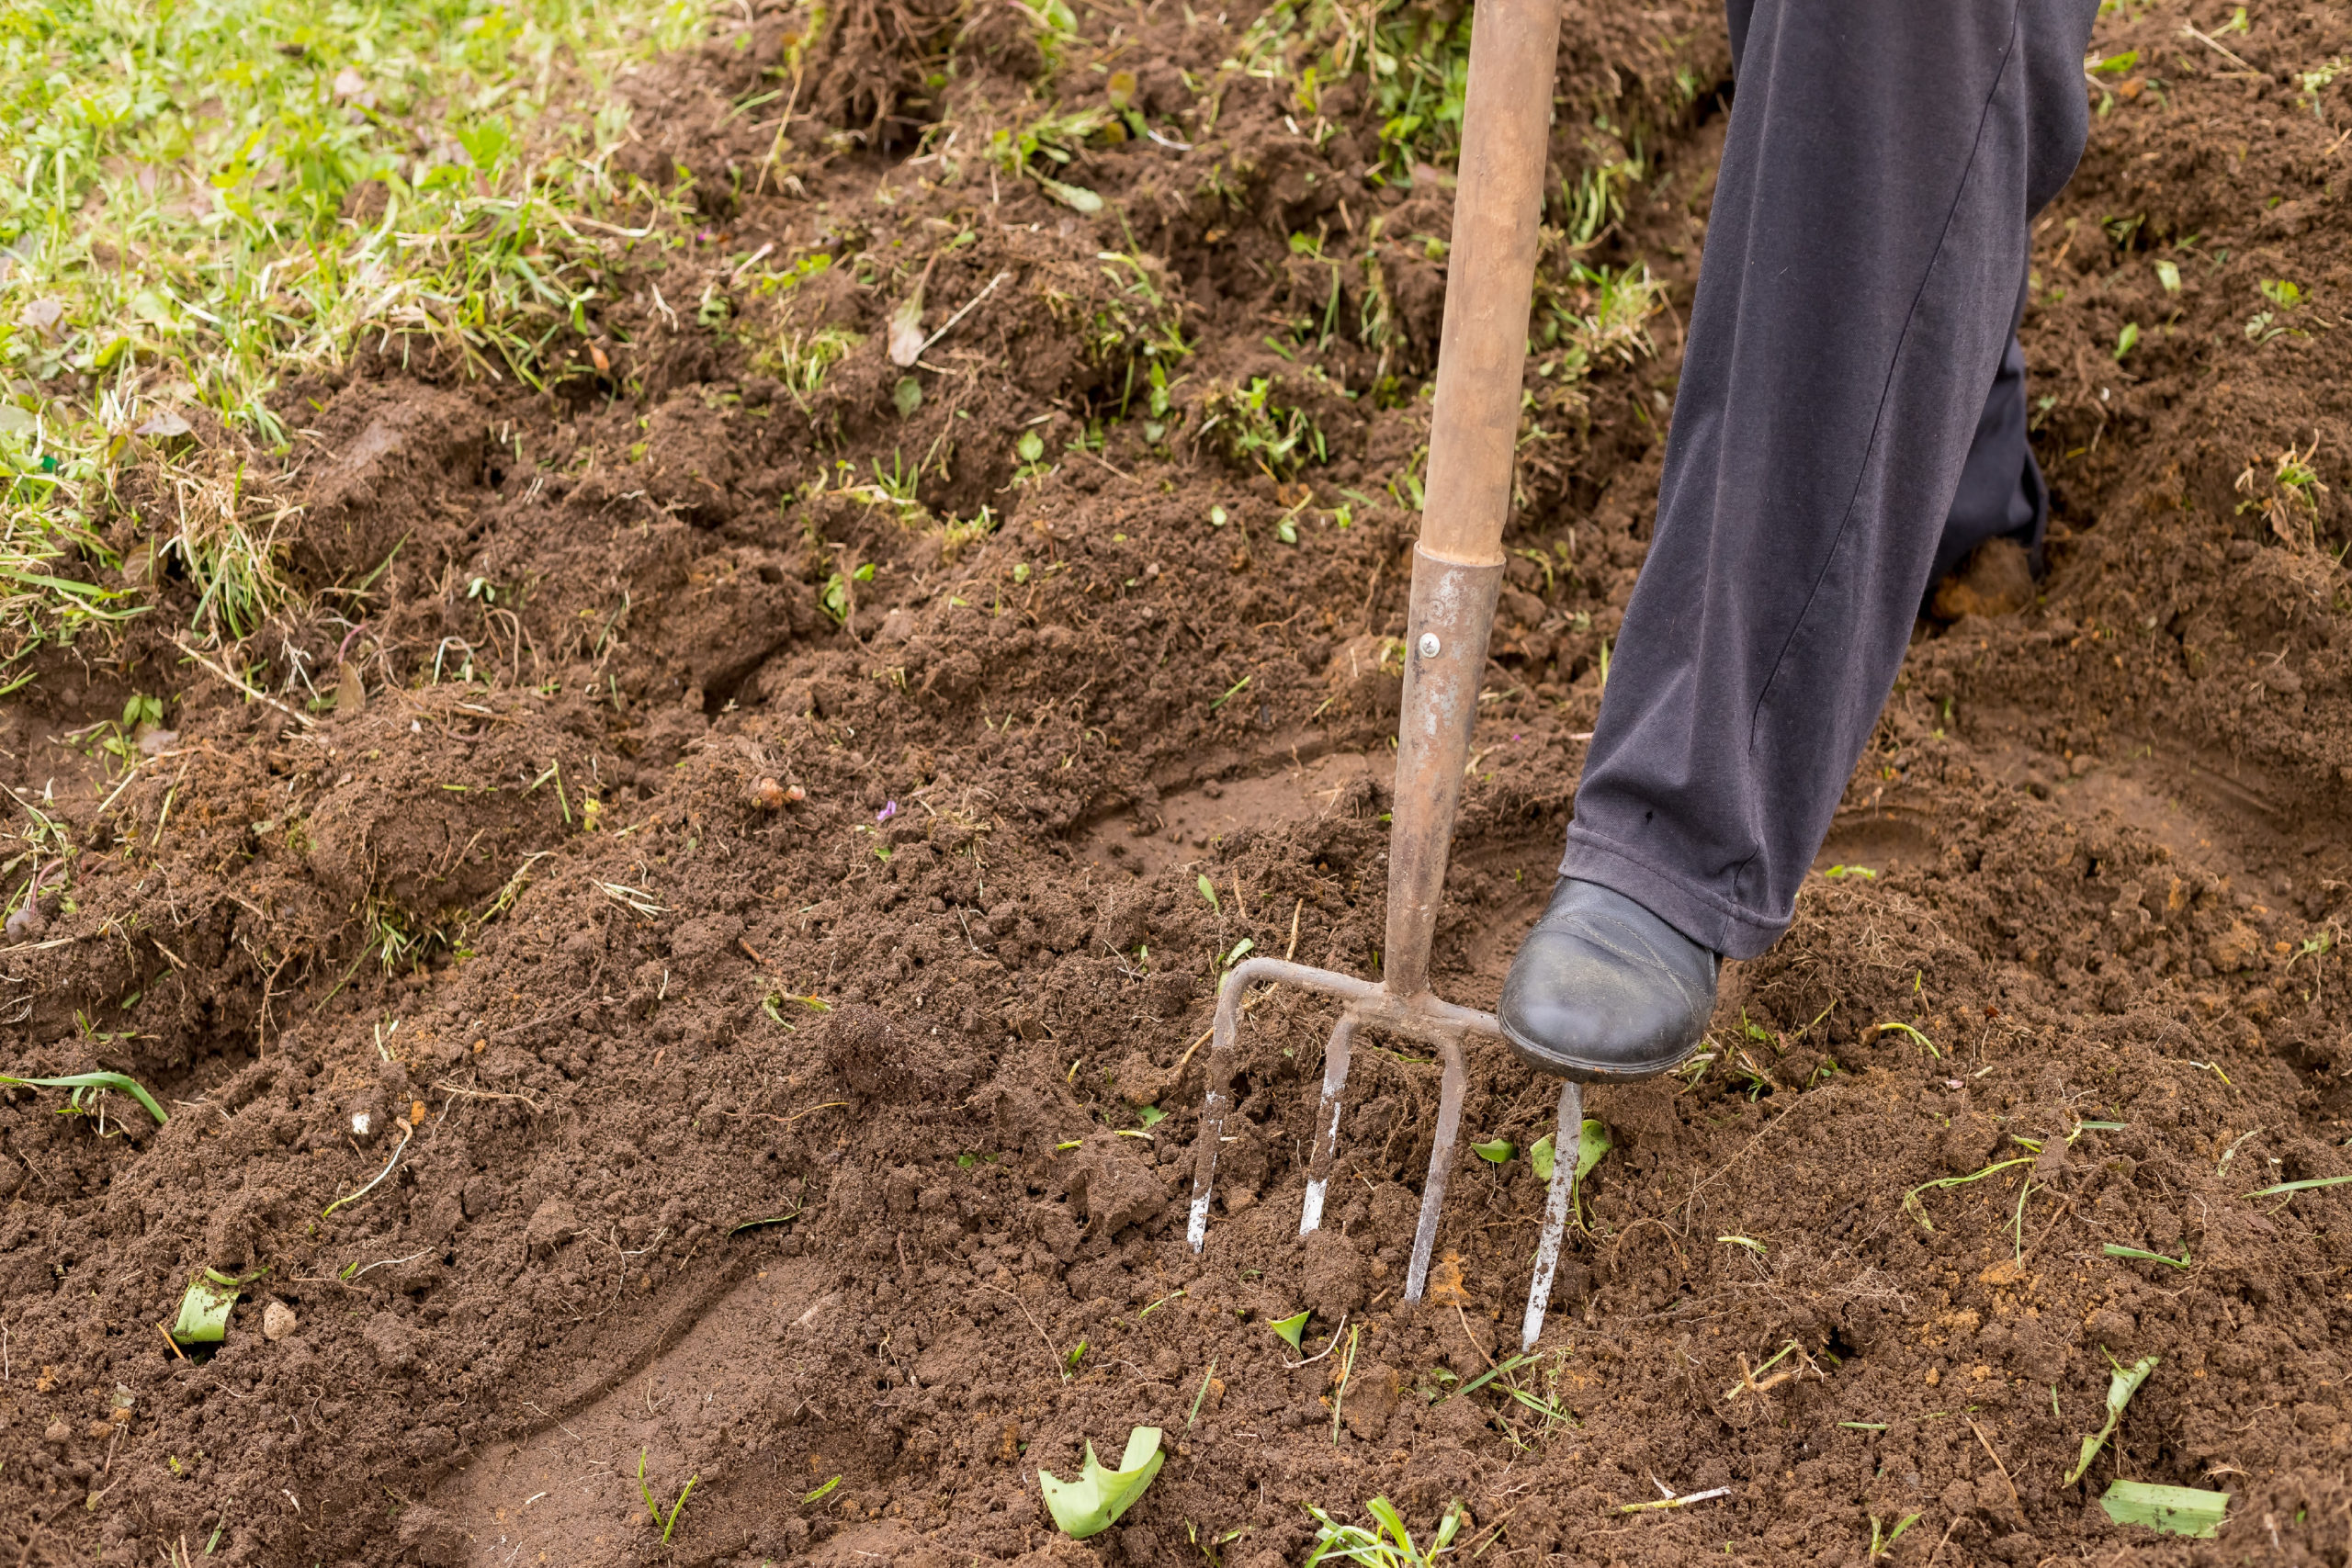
[1185,0,1583,1347]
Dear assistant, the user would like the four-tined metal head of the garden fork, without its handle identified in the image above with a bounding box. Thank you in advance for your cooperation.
[1185,957,1583,1347]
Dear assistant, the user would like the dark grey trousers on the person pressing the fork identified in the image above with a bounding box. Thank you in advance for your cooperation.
[1562,0,2098,957]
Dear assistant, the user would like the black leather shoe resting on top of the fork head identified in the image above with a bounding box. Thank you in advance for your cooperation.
[1496,877,1717,1084]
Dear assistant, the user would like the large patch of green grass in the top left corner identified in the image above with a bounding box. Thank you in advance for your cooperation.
[0,0,706,682]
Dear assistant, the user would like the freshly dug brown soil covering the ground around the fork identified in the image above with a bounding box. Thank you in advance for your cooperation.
[0,0,2352,1568]
